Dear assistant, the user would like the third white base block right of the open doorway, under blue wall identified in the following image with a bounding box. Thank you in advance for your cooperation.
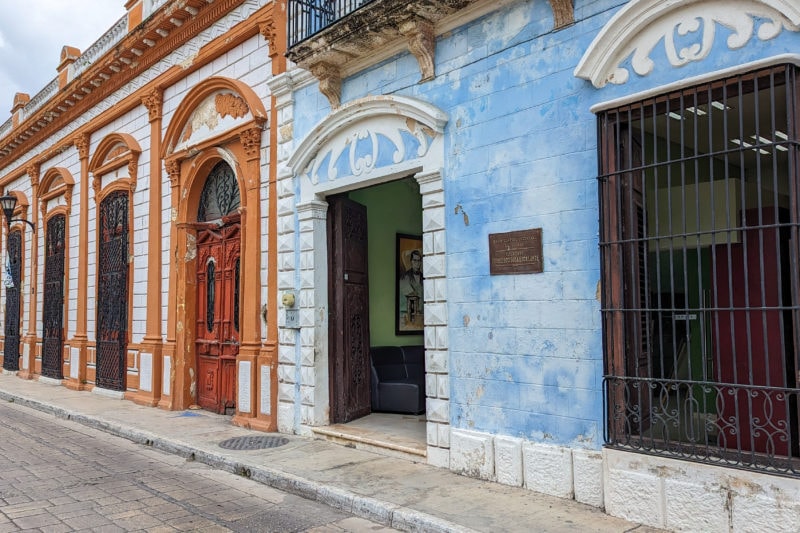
[522,442,573,499]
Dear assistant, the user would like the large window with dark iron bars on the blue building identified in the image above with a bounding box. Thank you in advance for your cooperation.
[598,65,800,477]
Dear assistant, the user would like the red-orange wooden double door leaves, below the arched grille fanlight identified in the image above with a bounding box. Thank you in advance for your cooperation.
[195,220,241,413]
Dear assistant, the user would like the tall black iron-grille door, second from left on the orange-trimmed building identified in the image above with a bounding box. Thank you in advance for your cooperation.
[42,215,67,379]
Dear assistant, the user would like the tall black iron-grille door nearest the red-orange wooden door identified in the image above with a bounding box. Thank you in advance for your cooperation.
[96,191,128,391]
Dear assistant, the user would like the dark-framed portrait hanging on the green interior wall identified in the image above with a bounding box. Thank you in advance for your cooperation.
[395,233,425,335]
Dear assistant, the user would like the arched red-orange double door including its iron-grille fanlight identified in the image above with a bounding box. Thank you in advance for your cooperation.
[195,161,241,414]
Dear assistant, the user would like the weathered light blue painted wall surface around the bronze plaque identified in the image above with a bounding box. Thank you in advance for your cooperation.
[294,0,800,448]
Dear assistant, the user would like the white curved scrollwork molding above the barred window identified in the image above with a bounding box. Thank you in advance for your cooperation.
[574,0,800,88]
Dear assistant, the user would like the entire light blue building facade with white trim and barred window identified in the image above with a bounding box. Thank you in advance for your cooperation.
[270,0,800,531]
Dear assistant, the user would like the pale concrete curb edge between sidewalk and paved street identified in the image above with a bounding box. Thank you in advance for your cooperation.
[0,390,474,533]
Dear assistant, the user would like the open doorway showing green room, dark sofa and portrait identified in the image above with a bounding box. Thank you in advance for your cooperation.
[323,177,426,455]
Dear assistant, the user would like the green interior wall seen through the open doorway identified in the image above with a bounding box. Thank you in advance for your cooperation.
[349,178,423,346]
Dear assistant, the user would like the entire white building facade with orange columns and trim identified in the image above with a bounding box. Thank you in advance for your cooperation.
[0,0,286,430]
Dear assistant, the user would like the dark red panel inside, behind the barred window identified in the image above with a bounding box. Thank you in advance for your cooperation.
[712,208,790,455]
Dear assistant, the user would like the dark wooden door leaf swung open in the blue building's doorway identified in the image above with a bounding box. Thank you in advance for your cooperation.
[328,196,372,423]
